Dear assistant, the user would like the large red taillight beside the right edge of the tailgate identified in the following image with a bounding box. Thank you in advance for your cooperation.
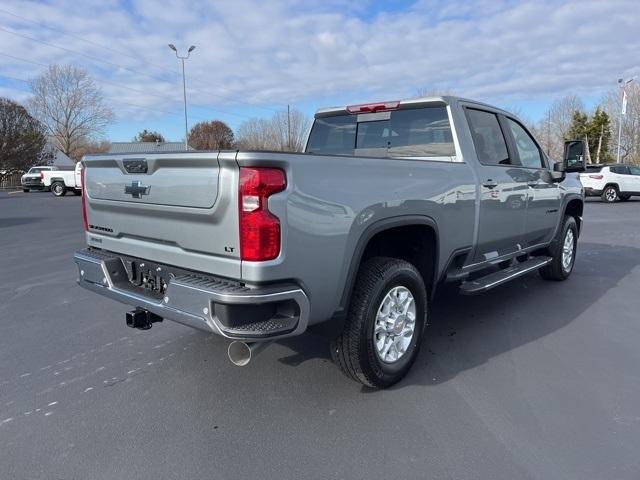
[239,167,287,262]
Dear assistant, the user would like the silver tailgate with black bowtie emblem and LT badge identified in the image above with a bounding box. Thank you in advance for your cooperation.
[84,152,240,278]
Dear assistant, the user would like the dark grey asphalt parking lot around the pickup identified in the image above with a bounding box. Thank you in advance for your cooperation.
[0,192,640,480]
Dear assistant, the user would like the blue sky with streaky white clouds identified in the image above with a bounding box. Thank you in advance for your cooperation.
[0,0,640,141]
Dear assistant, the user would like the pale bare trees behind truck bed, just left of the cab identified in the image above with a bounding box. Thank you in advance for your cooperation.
[238,110,311,152]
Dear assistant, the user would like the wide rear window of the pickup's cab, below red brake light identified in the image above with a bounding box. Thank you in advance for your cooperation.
[307,106,455,158]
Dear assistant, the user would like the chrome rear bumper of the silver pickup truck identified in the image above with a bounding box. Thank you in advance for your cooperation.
[74,249,309,341]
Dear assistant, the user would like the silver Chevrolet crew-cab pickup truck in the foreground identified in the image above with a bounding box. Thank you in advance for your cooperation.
[75,97,585,388]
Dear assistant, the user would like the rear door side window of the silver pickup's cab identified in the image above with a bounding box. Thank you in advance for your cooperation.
[467,108,512,165]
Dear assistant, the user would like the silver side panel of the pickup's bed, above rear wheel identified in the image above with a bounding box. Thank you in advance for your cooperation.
[237,152,476,324]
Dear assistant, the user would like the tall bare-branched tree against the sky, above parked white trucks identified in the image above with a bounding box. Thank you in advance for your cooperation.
[29,65,113,161]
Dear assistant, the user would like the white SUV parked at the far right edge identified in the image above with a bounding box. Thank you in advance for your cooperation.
[580,163,640,203]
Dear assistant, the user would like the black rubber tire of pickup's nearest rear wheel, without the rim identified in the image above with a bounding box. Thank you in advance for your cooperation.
[331,257,427,388]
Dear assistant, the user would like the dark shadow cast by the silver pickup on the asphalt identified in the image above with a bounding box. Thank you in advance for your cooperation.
[279,242,640,392]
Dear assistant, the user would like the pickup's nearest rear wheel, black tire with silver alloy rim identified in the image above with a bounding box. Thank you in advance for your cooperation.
[331,257,427,388]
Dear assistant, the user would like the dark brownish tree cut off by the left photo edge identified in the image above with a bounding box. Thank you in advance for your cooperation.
[0,98,46,183]
